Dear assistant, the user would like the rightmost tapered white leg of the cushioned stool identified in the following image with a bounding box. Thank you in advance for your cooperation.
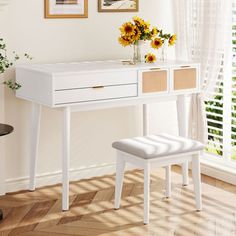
[192,155,202,211]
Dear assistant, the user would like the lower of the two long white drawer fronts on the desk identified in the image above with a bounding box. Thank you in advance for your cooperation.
[54,84,138,105]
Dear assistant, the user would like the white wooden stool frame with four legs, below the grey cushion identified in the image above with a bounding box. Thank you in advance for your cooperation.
[115,150,202,224]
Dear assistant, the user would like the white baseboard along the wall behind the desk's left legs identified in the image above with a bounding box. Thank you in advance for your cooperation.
[6,163,115,193]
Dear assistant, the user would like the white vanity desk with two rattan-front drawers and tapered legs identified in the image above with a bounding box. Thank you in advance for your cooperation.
[16,61,200,210]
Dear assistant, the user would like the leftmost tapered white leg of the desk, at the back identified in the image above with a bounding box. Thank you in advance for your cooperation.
[29,103,41,191]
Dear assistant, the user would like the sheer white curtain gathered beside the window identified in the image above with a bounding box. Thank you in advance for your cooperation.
[174,0,232,142]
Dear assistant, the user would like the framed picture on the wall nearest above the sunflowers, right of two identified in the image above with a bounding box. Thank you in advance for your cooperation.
[98,0,139,12]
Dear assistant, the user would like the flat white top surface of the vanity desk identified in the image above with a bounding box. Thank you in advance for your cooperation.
[16,60,197,74]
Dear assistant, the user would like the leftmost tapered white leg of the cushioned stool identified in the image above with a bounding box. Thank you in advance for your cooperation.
[115,151,125,209]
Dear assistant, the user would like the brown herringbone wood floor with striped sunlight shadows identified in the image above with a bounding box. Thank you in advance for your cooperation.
[0,167,236,236]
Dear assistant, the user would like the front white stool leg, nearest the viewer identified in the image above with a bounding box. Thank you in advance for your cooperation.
[143,163,150,224]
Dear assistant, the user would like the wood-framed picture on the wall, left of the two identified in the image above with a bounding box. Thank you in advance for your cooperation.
[45,0,88,18]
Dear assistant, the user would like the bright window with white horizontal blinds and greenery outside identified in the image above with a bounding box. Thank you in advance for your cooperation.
[205,1,236,166]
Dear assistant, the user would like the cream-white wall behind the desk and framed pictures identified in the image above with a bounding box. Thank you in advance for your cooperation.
[0,0,177,191]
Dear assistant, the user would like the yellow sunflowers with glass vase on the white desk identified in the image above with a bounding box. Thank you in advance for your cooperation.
[118,16,177,63]
